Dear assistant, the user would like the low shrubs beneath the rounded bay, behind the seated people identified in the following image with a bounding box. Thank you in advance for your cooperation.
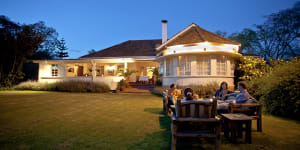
[177,82,220,98]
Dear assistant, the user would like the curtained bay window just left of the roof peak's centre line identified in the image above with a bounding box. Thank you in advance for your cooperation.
[178,56,191,76]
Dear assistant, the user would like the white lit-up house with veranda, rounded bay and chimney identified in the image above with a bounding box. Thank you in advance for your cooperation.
[35,20,241,89]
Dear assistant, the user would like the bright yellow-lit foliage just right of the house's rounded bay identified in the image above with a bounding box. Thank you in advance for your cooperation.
[235,57,267,80]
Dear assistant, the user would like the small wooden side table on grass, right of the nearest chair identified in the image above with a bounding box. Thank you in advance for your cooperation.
[221,113,254,143]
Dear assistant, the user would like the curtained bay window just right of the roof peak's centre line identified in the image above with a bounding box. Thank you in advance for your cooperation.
[197,56,210,75]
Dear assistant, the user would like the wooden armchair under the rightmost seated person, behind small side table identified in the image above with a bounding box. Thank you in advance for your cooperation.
[229,98,263,132]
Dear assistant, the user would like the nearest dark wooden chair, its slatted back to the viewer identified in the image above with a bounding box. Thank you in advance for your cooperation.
[171,100,221,150]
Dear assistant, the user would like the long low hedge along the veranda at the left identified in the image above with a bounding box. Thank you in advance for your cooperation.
[14,80,110,93]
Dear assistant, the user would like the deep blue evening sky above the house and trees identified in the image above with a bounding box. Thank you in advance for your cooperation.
[0,0,297,58]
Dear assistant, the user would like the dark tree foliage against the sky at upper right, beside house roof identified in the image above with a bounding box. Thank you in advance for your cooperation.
[229,2,300,60]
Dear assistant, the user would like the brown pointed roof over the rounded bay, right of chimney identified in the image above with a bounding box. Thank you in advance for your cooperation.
[157,23,240,50]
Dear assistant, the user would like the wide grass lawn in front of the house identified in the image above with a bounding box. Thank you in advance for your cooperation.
[0,91,300,150]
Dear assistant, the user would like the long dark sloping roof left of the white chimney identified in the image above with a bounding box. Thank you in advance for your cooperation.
[80,39,161,58]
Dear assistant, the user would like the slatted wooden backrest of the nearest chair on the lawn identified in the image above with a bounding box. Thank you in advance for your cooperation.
[176,100,217,118]
